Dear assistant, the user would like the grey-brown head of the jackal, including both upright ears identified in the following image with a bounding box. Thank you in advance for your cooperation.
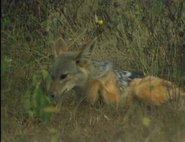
[49,38,96,98]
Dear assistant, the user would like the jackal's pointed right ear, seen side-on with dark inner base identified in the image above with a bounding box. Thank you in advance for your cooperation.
[76,37,97,65]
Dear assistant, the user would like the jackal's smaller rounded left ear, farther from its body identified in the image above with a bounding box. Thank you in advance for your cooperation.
[53,38,67,58]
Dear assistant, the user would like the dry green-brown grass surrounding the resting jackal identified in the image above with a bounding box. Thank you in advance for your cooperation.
[1,0,185,142]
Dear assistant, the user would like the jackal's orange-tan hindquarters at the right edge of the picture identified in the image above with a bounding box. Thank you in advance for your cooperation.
[128,76,185,106]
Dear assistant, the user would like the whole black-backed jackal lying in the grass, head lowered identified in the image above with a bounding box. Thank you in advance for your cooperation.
[49,38,185,106]
